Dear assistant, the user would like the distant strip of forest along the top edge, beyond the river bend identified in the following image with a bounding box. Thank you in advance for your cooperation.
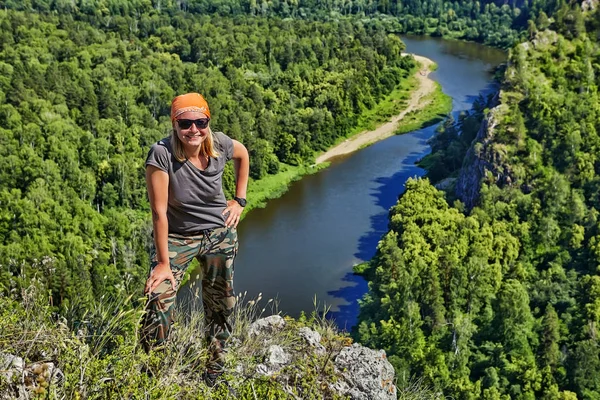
[0,0,561,47]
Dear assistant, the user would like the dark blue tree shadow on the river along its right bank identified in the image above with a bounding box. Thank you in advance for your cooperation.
[327,125,437,330]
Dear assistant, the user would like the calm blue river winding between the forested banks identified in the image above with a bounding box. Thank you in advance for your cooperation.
[179,37,506,329]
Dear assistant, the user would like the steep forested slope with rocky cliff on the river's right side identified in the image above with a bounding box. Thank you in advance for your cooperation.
[356,5,600,399]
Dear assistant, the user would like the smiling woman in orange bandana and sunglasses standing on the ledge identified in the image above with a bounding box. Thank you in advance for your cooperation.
[142,93,249,384]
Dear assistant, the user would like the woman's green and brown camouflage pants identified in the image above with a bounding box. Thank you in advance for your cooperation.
[141,227,238,372]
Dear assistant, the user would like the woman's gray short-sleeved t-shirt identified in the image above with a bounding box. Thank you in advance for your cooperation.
[146,132,233,235]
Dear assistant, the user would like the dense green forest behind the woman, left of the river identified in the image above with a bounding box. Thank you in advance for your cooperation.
[0,7,414,305]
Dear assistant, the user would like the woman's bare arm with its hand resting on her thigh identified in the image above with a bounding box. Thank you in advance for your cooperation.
[144,165,175,293]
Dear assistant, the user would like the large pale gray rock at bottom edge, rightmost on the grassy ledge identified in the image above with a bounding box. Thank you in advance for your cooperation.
[332,343,396,400]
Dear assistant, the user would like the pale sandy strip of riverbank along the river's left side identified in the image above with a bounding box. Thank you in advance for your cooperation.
[316,54,435,164]
